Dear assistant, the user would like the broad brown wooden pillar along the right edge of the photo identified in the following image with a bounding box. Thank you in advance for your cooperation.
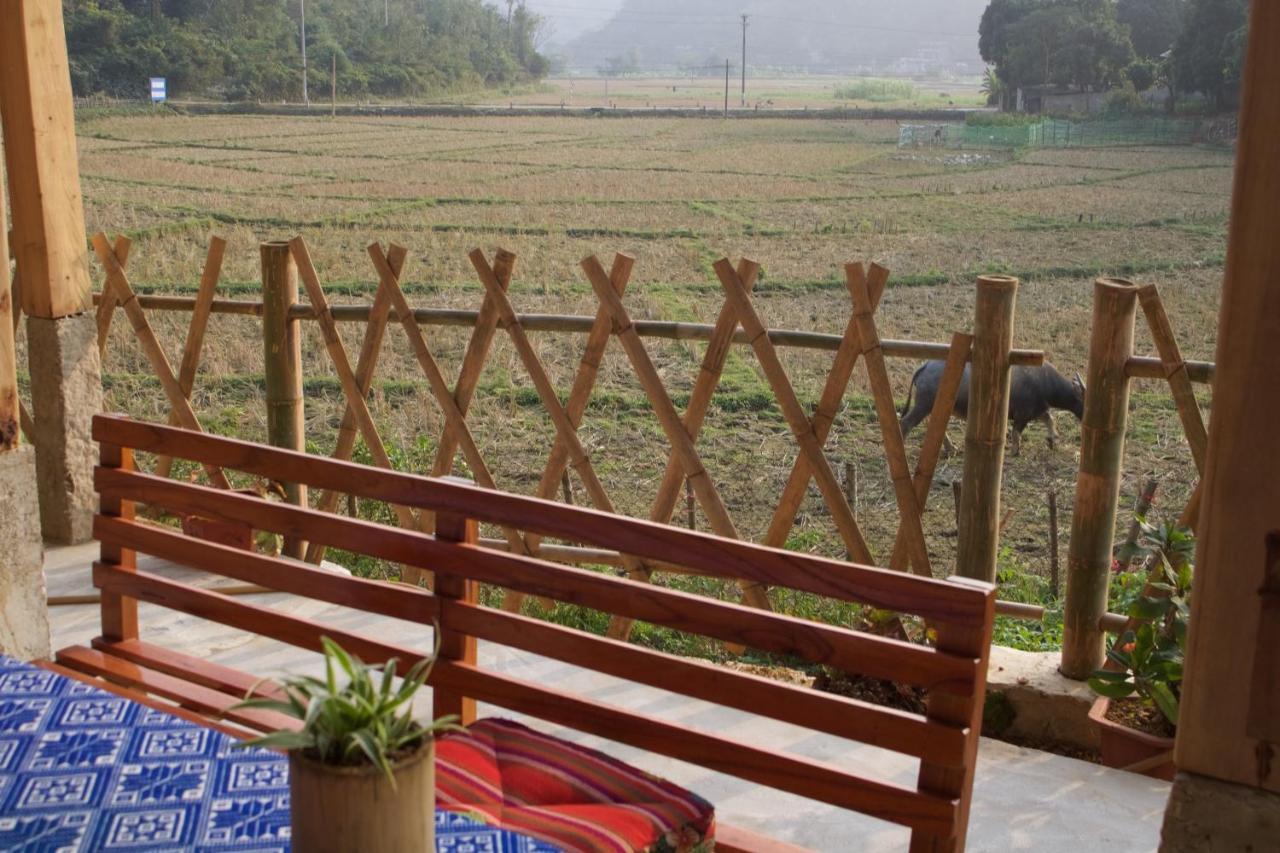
[1161,3,1280,853]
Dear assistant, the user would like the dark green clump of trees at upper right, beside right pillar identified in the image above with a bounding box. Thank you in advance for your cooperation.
[978,0,1248,110]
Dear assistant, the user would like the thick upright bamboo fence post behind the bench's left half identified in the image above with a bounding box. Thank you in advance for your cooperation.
[260,242,307,560]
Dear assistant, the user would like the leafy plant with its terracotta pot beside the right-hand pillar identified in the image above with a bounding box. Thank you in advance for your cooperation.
[1089,523,1194,780]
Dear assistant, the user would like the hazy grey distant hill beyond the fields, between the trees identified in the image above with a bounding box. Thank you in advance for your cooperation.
[564,0,988,72]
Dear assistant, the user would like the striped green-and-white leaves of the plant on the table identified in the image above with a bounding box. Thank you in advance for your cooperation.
[237,637,458,788]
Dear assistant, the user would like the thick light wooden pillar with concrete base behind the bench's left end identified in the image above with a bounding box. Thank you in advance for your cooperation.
[0,0,102,542]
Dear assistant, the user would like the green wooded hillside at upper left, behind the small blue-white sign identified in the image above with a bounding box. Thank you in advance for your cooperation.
[63,0,547,101]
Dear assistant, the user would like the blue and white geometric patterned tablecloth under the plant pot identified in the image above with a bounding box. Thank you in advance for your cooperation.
[0,654,558,853]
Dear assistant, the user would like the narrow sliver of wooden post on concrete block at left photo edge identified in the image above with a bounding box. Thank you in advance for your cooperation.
[0,144,50,660]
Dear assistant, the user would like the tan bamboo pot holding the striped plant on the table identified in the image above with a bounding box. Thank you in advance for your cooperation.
[289,740,435,853]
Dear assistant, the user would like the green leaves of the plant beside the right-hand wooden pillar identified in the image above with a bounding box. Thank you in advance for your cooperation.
[1089,545,1192,726]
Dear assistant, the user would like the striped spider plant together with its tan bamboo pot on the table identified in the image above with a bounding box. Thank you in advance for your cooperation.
[239,637,457,853]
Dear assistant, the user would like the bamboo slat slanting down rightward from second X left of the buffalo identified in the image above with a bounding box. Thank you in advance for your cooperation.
[714,259,874,565]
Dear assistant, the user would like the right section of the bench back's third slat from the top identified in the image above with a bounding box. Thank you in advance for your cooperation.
[442,602,968,766]
